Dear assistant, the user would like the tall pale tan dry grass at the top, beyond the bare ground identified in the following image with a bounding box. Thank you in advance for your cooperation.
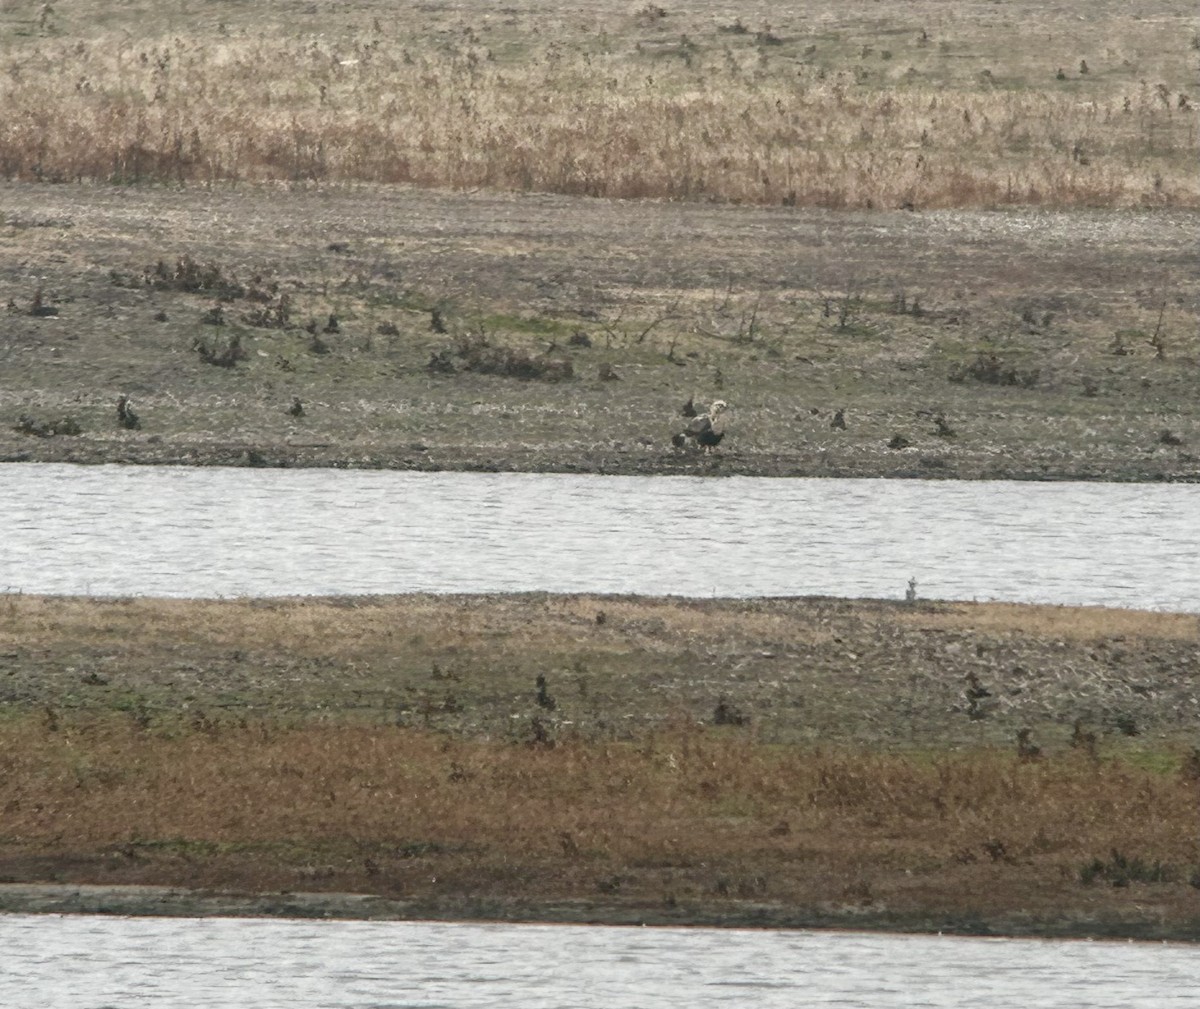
[0,2,1200,208]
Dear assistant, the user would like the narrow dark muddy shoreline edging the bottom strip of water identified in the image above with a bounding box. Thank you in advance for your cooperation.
[0,883,1200,943]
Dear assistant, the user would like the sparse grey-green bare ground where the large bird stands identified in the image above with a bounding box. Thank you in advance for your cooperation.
[7,184,1200,480]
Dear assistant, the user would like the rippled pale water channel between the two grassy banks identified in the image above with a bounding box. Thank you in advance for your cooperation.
[7,464,1200,611]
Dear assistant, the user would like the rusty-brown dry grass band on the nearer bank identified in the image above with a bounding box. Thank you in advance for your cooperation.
[0,719,1200,919]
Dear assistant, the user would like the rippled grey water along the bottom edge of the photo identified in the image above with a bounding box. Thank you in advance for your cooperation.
[0,915,1200,1009]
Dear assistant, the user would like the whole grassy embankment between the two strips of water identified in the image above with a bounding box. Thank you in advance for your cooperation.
[0,596,1200,937]
